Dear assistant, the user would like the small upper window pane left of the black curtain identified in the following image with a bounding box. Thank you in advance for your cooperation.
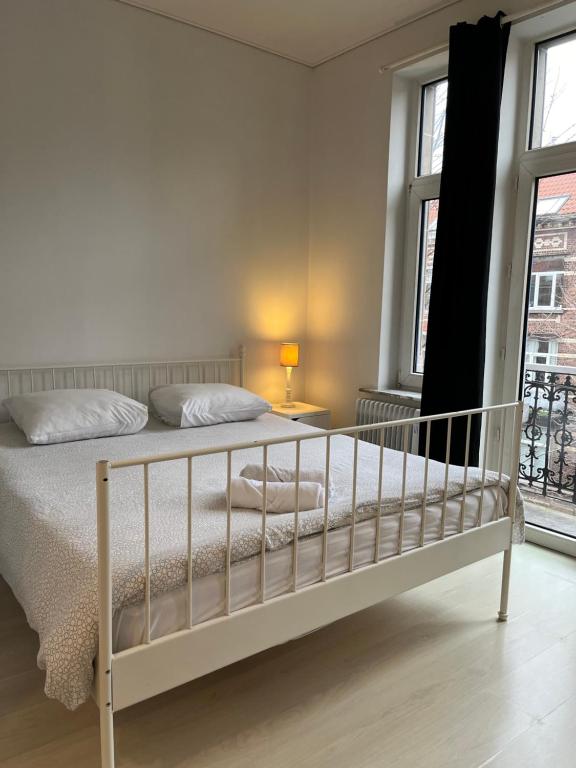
[418,79,448,176]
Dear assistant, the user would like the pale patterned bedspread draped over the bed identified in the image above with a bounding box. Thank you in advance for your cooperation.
[0,414,521,708]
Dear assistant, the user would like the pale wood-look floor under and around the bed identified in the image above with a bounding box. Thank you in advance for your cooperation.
[0,544,576,768]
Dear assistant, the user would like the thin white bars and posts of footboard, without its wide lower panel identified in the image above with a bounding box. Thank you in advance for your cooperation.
[96,402,522,768]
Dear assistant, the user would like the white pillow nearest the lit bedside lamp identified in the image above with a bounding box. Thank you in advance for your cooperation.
[150,384,272,427]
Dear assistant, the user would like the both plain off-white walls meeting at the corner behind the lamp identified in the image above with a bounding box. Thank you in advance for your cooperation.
[0,0,564,424]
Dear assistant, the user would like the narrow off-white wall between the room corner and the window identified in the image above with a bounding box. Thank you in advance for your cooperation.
[306,0,556,424]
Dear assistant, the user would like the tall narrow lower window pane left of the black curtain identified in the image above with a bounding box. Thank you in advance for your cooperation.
[414,200,438,373]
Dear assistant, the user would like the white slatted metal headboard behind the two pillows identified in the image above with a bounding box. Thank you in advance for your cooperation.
[0,347,246,422]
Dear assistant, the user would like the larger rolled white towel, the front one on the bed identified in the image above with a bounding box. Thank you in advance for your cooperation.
[230,477,324,513]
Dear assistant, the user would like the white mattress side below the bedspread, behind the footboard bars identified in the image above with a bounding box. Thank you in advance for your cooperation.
[112,486,508,653]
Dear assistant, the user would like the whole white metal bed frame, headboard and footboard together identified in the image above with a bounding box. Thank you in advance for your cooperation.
[0,348,522,768]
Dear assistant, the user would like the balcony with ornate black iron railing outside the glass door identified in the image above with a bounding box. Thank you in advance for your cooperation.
[519,365,576,537]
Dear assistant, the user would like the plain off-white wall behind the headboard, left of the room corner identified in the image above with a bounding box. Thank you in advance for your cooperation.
[0,0,310,399]
